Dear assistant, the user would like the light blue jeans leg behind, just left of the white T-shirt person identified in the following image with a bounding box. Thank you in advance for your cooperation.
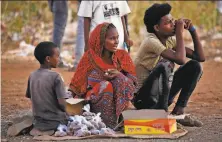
[74,2,85,68]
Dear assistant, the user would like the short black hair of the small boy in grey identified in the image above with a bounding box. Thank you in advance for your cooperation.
[34,41,58,64]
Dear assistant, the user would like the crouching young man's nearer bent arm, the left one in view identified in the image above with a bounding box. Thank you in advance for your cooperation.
[161,19,186,65]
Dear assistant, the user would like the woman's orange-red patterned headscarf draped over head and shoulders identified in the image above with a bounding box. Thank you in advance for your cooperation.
[70,23,136,97]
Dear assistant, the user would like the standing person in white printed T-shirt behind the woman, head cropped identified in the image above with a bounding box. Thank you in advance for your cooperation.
[78,1,133,51]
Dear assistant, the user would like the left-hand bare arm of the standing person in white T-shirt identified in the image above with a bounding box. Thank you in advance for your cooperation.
[84,17,91,52]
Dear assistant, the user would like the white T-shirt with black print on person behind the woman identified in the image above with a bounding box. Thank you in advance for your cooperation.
[78,1,131,49]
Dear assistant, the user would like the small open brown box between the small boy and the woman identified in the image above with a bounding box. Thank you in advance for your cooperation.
[66,98,84,115]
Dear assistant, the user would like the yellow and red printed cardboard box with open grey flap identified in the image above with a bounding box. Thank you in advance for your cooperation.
[123,109,177,135]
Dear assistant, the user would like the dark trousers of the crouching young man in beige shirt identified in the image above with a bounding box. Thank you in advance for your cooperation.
[134,60,203,111]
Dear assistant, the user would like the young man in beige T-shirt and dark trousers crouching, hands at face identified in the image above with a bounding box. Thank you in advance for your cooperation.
[134,3,205,115]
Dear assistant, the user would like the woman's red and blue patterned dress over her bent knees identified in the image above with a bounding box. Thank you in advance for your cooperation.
[86,70,135,128]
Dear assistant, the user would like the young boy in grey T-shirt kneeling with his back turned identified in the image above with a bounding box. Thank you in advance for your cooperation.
[9,41,69,136]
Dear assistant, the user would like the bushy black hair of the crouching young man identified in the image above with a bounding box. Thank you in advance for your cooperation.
[143,3,171,33]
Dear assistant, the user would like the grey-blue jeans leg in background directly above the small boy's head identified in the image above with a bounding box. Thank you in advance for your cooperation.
[48,0,68,50]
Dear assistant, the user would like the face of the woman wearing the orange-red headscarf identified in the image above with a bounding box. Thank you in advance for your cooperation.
[105,28,119,52]
